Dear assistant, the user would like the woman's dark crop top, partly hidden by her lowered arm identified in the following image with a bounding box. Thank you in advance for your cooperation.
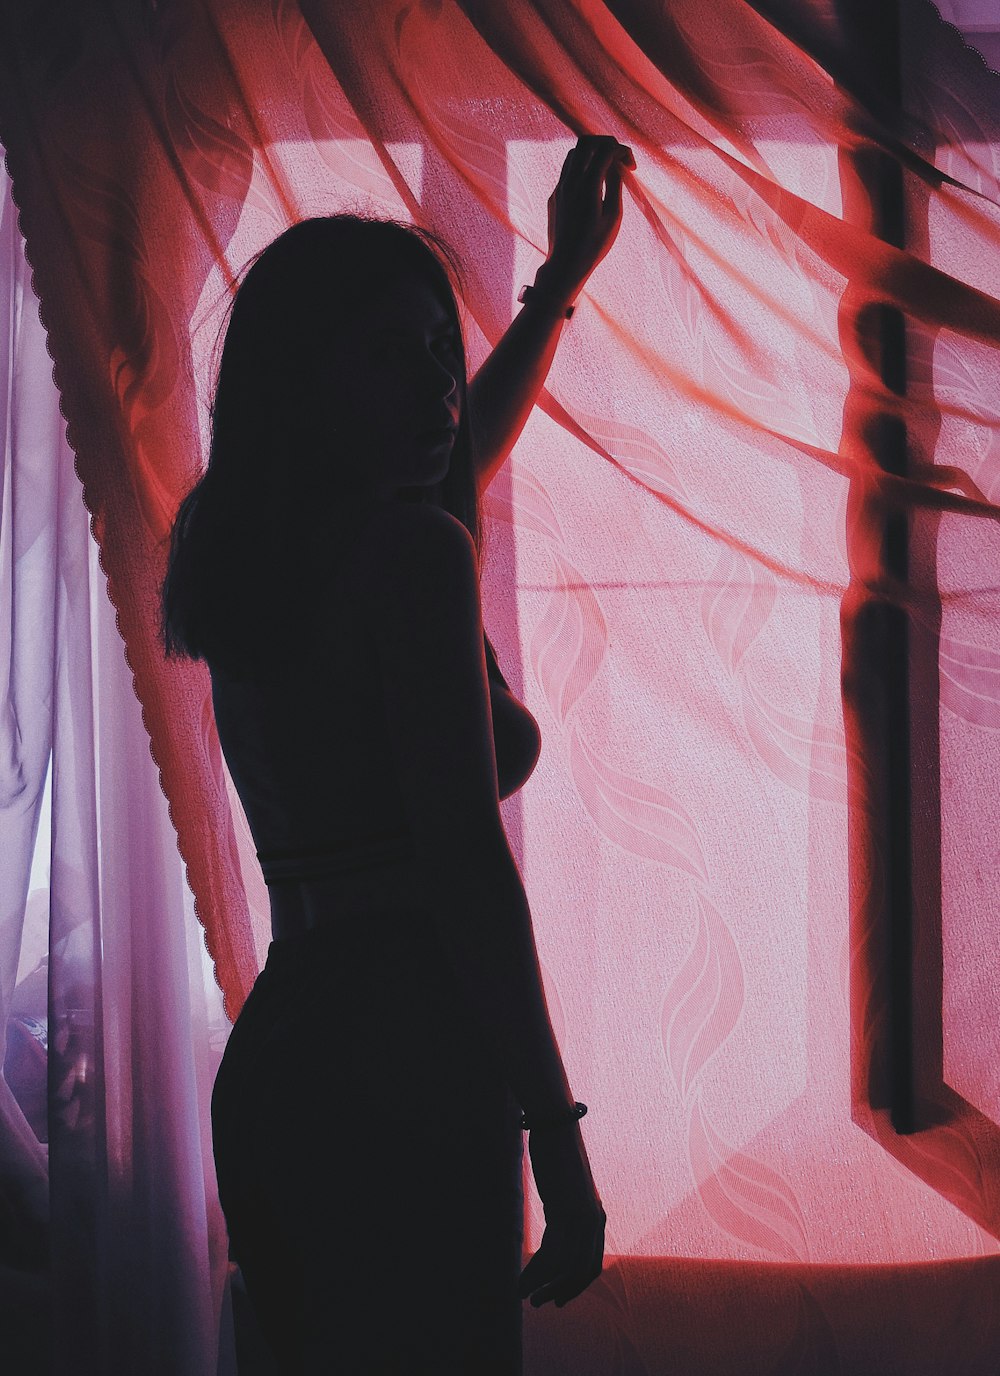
[209,608,541,885]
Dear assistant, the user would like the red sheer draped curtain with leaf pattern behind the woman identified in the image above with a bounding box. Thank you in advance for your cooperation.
[0,0,1000,1370]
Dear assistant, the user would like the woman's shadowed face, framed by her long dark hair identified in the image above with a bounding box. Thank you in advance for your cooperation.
[329,277,462,499]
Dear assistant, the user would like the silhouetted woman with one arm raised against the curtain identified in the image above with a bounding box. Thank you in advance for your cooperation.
[162,138,634,1376]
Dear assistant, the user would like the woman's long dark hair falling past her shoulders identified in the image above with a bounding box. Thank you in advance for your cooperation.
[160,215,483,676]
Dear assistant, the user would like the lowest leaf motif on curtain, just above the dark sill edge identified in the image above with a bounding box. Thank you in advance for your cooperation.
[688,1099,809,1262]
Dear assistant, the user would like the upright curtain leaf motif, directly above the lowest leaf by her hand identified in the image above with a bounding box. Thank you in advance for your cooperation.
[660,894,744,1099]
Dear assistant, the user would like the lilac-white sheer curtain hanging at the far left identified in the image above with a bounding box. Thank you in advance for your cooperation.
[0,163,235,1376]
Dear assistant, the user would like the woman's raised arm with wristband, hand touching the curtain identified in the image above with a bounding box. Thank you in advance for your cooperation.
[469,135,635,493]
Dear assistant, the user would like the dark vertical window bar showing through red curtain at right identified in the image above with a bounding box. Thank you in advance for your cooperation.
[838,0,917,1134]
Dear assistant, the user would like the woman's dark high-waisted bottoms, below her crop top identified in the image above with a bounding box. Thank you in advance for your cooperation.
[212,904,524,1376]
